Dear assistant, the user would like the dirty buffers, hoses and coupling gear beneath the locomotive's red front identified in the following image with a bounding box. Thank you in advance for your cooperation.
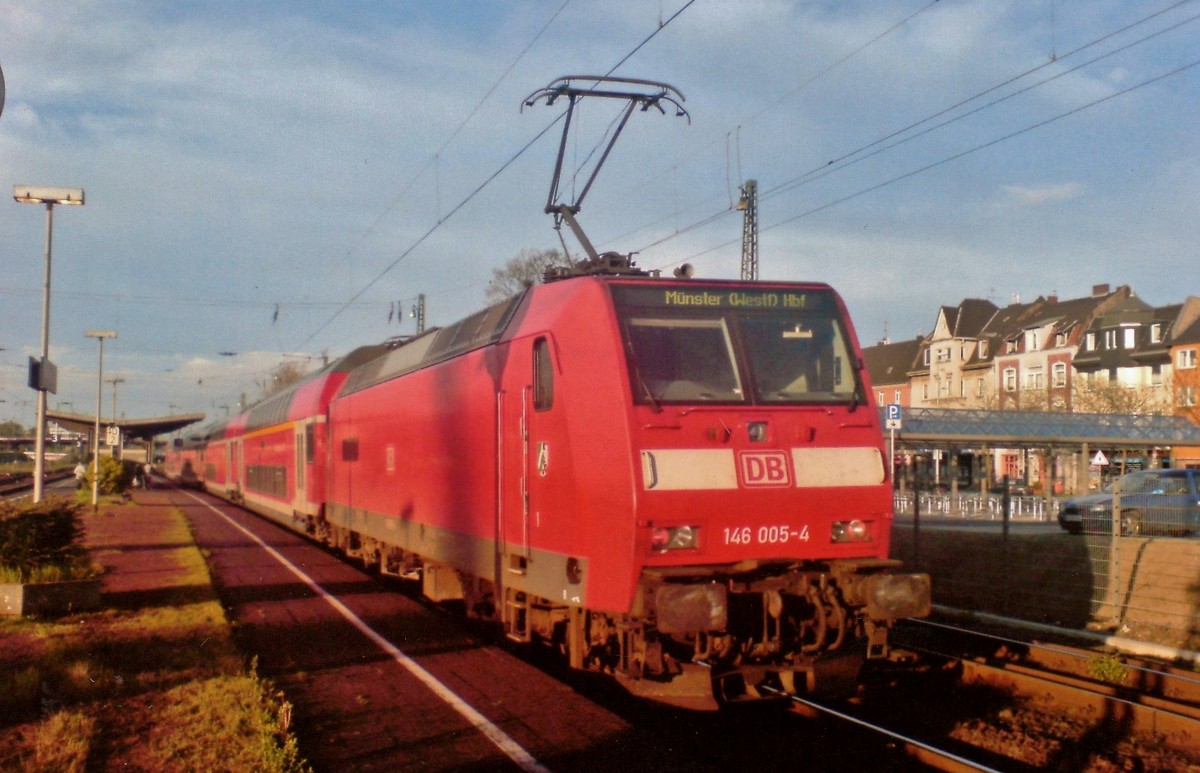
[593,558,931,708]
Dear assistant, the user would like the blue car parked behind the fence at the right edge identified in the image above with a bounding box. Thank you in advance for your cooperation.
[1058,469,1200,537]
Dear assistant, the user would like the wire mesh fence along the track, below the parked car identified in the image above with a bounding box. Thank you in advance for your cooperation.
[892,492,1200,651]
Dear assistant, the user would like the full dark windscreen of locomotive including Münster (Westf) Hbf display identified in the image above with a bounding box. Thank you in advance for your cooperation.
[612,286,862,405]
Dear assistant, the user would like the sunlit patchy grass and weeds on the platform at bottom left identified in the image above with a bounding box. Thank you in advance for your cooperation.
[0,511,308,772]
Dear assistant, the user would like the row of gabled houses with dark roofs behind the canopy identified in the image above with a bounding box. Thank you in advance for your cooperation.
[864,284,1200,477]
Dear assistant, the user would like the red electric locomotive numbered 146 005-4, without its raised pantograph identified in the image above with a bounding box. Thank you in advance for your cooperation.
[317,256,930,706]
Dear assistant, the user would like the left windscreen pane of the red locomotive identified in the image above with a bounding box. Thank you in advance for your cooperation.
[625,317,743,403]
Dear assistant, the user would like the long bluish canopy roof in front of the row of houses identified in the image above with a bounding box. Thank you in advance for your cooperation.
[880,407,1200,448]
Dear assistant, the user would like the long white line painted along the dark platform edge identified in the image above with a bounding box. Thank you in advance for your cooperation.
[184,491,550,773]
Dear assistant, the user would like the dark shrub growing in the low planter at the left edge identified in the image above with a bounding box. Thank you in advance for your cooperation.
[0,497,89,582]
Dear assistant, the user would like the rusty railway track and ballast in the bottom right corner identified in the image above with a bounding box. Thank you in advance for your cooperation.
[854,623,1200,771]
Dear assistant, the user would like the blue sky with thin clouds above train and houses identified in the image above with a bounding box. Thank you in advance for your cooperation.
[0,0,1200,425]
